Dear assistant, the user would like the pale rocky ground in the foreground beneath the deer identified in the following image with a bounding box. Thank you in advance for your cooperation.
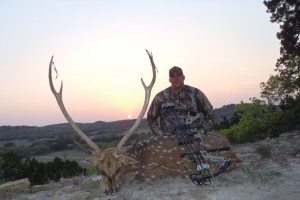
[1,131,300,200]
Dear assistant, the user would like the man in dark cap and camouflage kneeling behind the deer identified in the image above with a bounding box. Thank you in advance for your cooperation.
[147,66,213,135]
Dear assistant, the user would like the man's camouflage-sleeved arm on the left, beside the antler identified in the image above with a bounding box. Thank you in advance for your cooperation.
[147,95,163,135]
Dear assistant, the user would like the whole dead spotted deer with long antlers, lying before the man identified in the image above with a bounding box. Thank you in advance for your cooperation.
[49,50,238,194]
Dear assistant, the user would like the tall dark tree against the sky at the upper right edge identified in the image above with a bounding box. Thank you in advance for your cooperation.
[261,0,300,103]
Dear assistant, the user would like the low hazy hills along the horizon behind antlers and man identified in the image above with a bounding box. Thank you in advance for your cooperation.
[0,104,235,141]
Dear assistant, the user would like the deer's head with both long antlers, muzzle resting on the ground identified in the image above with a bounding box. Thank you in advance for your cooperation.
[49,50,156,194]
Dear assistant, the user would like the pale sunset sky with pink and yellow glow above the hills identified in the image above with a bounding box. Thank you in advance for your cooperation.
[0,0,279,126]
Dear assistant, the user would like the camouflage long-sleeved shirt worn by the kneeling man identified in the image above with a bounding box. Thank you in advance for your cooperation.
[147,85,213,135]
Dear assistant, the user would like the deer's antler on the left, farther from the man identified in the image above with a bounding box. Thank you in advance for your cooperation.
[49,56,101,153]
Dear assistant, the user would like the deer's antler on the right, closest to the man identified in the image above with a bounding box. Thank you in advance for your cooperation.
[115,49,156,154]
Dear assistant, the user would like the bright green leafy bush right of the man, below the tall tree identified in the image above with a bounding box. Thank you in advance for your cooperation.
[219,98,288,143]
